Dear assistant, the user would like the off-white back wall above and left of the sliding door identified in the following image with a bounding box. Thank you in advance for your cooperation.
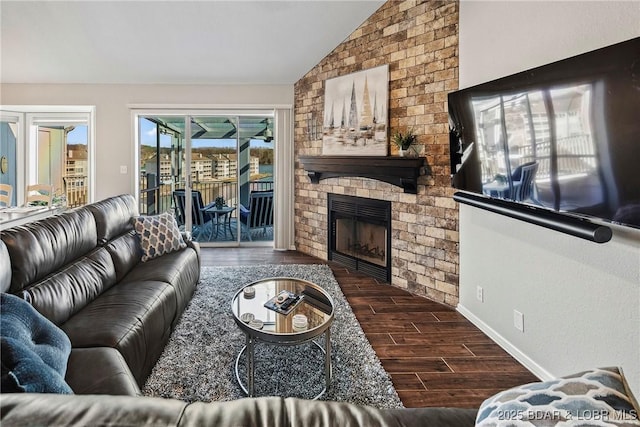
[0,84,293,200]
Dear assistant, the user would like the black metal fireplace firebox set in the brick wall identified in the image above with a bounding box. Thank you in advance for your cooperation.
[328,193,391,282]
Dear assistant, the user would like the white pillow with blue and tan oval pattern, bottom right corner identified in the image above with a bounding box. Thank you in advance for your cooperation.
[476,368,640,426]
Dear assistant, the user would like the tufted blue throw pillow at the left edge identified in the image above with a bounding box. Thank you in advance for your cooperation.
[0,293,73,394]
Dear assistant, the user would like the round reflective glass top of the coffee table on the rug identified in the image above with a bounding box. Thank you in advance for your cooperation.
[231,277,333,341]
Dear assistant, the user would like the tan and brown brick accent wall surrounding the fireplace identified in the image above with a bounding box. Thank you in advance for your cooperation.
[294,1,459,306]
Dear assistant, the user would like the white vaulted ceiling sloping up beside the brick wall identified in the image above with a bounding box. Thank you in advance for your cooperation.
[0,0,384,84]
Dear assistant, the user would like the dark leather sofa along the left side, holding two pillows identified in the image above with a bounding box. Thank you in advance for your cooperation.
[0,195,200,395]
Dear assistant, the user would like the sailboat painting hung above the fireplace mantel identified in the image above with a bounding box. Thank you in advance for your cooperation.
[322,65,389,156]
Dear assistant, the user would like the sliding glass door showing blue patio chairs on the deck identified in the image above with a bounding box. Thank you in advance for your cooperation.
[136,112,274,246]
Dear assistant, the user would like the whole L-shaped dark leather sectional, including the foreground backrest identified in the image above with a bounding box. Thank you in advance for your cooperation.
[0,195,477,427]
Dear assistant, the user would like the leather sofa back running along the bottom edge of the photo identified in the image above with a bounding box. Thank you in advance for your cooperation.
[0,394,476,427]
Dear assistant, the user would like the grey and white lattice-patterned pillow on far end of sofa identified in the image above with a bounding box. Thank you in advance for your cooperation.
[133,212,187,262]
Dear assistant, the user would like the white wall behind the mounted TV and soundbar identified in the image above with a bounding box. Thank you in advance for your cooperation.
[458,0,640,395]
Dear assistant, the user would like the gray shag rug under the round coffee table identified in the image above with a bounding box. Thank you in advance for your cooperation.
[142,264,403,408]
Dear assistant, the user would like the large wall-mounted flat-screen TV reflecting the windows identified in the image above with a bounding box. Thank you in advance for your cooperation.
[448,37,640,228]
